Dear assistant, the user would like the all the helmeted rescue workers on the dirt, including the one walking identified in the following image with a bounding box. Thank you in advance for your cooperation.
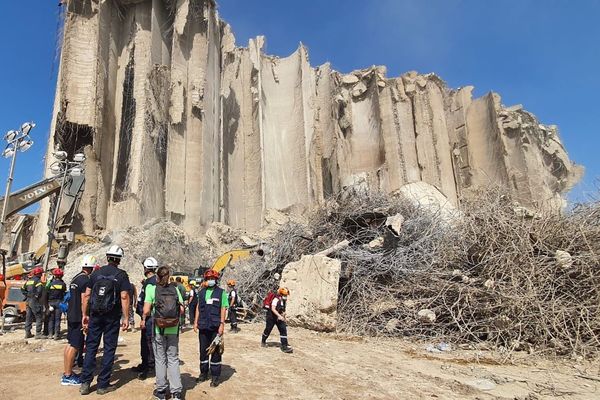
[22,246,292,399]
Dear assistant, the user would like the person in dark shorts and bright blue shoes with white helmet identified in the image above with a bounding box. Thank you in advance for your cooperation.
[60,254,97,386]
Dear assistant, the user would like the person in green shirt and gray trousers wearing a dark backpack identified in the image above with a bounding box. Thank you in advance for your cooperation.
[141,267,184,400]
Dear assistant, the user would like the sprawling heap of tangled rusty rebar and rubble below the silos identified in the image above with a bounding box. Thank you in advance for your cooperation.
[234,189,600,354]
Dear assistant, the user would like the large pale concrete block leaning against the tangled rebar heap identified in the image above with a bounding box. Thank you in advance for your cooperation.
[280,255,342,332]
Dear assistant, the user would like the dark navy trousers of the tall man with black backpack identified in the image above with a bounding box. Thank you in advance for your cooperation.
[81,315,121,389]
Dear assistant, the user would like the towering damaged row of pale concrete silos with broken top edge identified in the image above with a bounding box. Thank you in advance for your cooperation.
[37,0,582,240]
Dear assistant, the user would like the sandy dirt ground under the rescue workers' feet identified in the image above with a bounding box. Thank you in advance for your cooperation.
[0,324,600,400]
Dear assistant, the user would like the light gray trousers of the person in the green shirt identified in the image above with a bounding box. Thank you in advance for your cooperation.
[152,333,183,394]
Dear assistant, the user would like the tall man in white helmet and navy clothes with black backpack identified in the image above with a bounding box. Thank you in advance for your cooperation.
[79,246,131,395]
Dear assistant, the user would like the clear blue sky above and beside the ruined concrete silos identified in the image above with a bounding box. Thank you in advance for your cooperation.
[0,0,600,205]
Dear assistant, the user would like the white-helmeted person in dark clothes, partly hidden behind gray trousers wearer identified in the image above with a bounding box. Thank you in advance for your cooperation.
[132,257,158,380]
